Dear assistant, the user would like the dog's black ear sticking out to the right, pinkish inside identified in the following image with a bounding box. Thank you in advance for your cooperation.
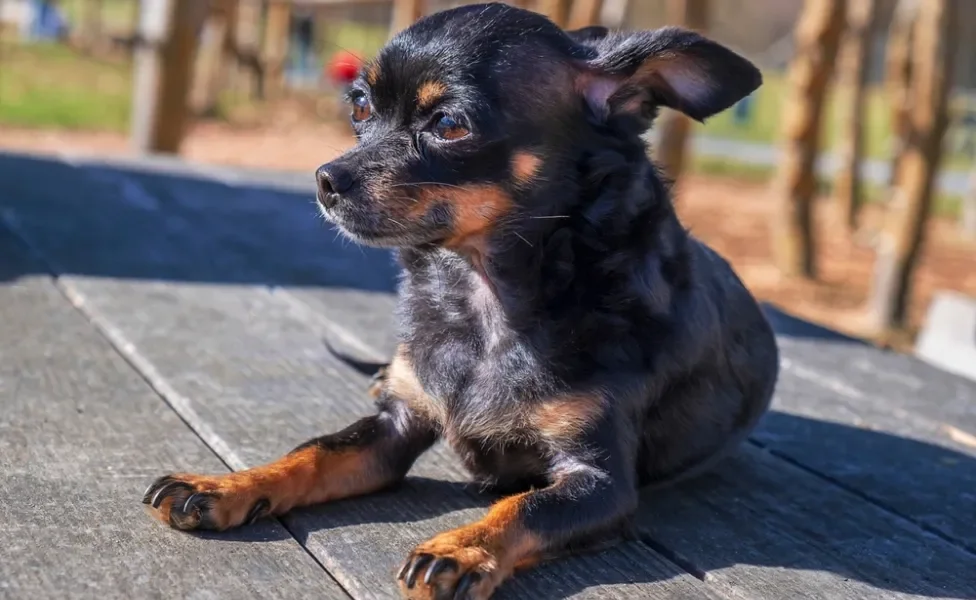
[577,27,762,126]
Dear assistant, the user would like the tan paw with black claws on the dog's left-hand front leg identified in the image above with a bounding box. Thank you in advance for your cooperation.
[142,473,271,531]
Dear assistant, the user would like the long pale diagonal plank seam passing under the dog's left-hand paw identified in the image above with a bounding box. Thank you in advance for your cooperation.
[0,210,355,600]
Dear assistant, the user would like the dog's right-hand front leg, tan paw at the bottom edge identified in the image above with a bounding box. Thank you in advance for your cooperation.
[398,446,637,600]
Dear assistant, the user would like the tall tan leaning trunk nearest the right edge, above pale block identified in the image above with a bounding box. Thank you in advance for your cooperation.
[868,0,957,333]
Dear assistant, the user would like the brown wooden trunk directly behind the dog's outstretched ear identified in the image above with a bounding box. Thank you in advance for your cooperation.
[656,0,708,181]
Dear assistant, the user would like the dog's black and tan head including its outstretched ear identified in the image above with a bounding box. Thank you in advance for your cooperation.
[316,4,761,248]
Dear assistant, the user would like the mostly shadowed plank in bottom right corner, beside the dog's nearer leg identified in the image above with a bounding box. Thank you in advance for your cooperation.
[638,448,976,598]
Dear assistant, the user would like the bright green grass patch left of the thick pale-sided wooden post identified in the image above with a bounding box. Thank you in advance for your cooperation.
[0,42,131,131]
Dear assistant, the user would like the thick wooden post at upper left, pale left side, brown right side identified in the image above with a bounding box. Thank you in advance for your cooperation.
[130,0,208,154]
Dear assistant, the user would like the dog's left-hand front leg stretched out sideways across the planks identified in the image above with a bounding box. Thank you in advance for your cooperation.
[142,397,437,530]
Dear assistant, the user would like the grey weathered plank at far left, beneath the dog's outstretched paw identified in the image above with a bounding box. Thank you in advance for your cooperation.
[0,226,347,599]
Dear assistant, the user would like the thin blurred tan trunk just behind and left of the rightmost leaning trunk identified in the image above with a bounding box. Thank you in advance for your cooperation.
[885,0,919,190]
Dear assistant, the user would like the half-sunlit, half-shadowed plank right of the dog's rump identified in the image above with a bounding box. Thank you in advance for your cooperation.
[753,369,976,549]
